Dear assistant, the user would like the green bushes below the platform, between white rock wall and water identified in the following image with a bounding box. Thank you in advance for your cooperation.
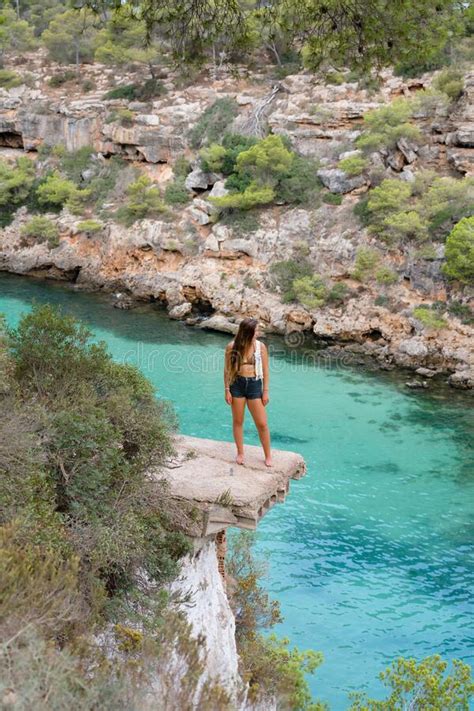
[227,532,326,711]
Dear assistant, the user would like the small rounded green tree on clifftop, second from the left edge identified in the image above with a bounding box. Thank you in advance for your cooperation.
[41,8,97,67]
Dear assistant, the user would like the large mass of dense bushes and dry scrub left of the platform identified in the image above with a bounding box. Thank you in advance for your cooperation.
[0,305,229,711]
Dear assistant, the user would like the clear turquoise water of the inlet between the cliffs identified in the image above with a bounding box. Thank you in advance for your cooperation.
[0,274,474,711]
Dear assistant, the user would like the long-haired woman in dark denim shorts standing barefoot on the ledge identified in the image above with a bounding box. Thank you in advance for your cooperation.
[224,318,272,467]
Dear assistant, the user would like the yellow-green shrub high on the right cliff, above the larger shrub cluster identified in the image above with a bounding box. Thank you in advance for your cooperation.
[356,99,421,153]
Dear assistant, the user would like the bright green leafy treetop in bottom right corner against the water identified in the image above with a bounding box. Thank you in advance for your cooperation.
[349,654,474,711]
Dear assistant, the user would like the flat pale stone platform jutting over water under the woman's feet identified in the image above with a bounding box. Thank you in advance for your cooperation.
[151,435,306,542]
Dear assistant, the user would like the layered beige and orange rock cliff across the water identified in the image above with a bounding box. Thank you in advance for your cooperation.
[0,58,474,387]
